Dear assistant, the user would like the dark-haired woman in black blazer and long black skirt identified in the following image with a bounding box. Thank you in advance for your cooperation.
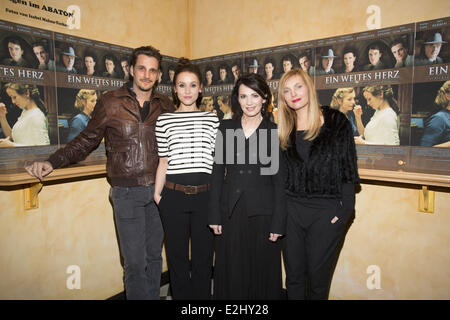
[208,74,286,299]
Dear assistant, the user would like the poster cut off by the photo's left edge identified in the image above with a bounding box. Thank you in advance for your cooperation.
[0,21,58,148]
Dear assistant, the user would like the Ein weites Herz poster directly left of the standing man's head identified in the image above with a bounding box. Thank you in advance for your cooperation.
[54,33,132,144]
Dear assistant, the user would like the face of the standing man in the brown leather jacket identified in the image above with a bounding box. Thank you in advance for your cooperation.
[130,54,160,93]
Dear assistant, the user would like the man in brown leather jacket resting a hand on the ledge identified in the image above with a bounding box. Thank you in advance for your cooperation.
[25,46,174,300]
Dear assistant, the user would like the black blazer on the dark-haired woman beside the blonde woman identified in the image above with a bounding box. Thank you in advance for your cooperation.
[208,119,286,234]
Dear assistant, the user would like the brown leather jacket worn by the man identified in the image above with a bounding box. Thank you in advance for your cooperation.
[48,84,174,186]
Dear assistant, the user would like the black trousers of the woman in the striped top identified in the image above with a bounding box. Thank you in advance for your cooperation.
[159,188,214,300]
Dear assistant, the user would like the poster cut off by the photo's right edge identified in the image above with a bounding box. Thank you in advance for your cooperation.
[410,18,450,172]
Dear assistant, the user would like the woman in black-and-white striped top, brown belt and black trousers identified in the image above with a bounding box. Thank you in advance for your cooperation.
[154,58,219,299]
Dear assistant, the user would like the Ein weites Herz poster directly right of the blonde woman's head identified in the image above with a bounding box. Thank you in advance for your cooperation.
[311,24,414,152]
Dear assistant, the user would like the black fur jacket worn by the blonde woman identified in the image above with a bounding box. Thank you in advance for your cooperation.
[283,107,359,198]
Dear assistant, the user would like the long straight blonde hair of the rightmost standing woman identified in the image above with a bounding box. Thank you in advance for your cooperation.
[278,68,322,150]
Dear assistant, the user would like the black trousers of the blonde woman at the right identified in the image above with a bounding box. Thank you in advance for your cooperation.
[283,198,354,300]
